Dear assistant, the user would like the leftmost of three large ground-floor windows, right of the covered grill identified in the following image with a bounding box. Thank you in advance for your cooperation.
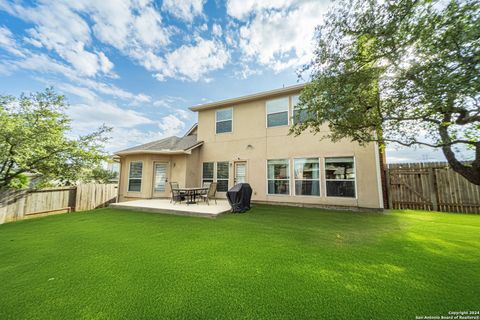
[267,159,290,195]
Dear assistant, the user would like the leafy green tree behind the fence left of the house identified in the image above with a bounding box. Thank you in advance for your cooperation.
[0,89,110,189]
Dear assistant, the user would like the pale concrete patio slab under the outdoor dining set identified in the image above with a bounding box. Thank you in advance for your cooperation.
[110,199,231,218]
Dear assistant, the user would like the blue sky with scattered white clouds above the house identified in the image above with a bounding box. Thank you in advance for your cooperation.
[0,0,450,161]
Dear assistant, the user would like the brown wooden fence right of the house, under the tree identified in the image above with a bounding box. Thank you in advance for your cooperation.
[385,162,480,213]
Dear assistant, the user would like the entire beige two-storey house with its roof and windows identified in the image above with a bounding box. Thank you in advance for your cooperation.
[116,84,383,208]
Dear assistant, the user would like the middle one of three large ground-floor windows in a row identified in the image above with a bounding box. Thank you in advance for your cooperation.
[294,158,320,196]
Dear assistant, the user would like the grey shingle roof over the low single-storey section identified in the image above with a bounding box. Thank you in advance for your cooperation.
[115,135,203,154]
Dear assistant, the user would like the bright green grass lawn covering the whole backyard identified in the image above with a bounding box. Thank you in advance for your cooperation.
[0,206,480,319]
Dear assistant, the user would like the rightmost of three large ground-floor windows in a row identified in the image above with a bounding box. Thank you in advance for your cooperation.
[325,157,356,198]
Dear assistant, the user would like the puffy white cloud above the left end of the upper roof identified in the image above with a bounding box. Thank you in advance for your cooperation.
[154,38,230,81]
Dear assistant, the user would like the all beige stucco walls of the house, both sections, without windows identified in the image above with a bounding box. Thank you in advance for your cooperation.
[115,85,383,208]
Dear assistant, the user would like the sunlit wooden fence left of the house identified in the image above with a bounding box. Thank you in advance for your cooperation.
[0,184,117,224]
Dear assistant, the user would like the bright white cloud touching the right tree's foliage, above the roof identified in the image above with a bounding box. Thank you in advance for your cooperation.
[240,1,327,72]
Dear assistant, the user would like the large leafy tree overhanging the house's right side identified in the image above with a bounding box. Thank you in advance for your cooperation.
[291,0,480,185]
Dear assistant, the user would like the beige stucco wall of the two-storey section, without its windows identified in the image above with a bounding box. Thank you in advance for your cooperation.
[196,90,383,208]
